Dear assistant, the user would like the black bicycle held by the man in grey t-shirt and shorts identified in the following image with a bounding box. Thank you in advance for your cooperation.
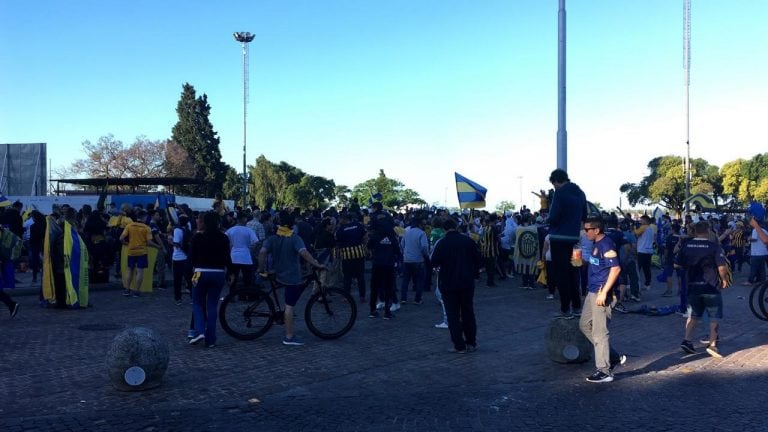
[219,269,357,340]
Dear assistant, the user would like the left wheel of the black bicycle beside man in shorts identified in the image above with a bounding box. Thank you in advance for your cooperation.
[219,289,275,340]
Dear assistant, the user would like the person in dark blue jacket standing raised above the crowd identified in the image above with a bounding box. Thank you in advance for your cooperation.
[549,168,587,319]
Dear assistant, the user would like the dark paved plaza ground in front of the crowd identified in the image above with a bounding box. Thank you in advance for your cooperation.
[0,266,768,432]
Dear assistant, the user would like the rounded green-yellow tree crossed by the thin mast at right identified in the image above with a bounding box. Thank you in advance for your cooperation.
[619,156,723,213]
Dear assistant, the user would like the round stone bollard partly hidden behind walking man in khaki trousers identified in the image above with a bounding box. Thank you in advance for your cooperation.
[546,318,593,363]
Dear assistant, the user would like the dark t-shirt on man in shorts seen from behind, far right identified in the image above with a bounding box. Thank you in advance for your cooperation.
[675,238,725,292]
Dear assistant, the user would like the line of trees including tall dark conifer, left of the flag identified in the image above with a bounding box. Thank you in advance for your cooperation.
[57,83,426,208]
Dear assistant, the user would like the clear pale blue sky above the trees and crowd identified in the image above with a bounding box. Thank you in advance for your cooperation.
[0,0,768,212]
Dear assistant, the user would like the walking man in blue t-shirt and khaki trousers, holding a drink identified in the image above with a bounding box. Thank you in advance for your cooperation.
[579,216,627,383]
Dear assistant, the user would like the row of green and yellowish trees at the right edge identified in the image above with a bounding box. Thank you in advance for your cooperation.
[620,153,768,213]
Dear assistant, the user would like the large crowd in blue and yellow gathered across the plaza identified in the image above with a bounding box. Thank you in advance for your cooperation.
[0,169,768,382]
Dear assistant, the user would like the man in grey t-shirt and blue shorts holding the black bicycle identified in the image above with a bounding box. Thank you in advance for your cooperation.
[259,210,324,345]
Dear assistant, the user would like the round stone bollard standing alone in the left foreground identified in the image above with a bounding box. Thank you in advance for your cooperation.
[106,327,169,391]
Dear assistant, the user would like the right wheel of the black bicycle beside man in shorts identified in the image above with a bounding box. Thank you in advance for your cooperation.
[304,288,357,339]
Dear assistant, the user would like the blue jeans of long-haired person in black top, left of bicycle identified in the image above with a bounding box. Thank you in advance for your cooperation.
[192,271,226,345]
